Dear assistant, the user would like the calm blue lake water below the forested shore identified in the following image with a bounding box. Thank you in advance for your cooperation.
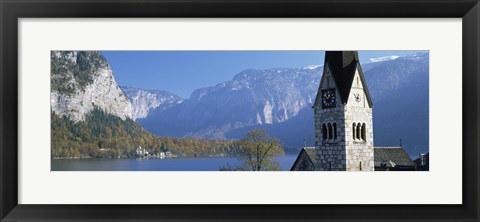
[52,155,297,171]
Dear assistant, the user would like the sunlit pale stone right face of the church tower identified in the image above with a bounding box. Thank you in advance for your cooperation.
[344,70,374,171]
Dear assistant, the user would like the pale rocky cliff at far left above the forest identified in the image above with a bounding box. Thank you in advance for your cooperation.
[50,51,132,122]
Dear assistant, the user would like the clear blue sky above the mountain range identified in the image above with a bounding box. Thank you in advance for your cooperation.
[101,51,425,98]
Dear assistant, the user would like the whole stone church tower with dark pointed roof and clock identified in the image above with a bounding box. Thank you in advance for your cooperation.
[313,51,374,171]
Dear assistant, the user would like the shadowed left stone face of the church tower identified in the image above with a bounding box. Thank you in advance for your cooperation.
[313,65,347,171]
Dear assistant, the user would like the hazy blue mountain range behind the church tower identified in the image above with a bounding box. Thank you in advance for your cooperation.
[122,53,429,157]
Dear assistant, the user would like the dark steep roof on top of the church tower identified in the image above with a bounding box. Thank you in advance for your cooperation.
[315,51,373,107]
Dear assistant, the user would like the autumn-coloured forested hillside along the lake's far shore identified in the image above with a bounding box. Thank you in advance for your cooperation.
[51,108,236,158]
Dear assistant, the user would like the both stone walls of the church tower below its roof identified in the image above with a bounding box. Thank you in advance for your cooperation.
[314,67,374,171]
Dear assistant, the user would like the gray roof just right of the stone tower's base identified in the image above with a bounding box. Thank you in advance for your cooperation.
[373,147,415,167]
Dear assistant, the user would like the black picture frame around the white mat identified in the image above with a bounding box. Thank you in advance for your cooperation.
[0,0,480,221]
